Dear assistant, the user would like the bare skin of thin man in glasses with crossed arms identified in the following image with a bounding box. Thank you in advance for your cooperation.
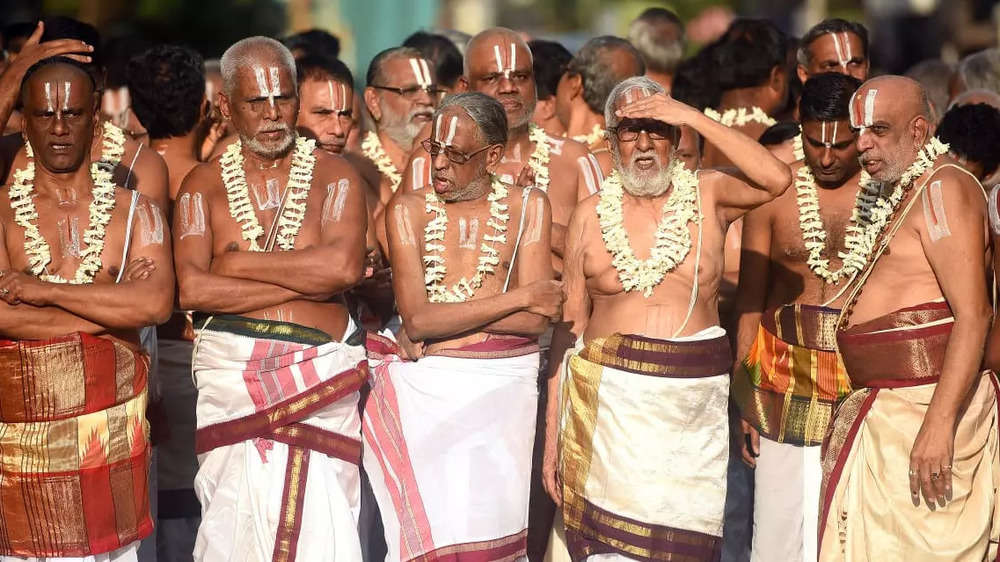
[386,106,563,357]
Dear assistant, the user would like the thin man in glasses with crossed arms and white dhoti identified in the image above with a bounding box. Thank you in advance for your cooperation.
[364,89,563,562]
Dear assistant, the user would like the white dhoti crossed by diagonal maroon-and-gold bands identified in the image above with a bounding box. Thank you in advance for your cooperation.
[192,316,367,562]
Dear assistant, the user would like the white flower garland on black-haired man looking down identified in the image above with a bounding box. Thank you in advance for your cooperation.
[795,164,878,285]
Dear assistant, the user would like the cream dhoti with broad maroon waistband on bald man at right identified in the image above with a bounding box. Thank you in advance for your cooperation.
[819,302,1000,562]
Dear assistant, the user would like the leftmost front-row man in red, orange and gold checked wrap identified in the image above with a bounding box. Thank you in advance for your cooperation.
[0,55,174,561]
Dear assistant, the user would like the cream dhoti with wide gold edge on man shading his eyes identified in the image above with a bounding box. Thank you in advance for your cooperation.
[560,327,732,562]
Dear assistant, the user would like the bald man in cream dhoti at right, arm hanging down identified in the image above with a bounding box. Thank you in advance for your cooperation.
[819,76,1000,561]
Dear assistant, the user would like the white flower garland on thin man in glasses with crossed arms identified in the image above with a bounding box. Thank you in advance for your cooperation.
[423,175,510,302]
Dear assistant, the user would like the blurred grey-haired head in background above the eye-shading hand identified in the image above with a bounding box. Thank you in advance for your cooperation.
[628,7,684,93]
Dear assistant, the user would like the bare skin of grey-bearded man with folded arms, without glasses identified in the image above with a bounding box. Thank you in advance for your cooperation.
[173,47,367,340]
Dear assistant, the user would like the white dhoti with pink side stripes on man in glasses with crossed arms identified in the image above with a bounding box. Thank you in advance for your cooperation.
[364,335,539,562]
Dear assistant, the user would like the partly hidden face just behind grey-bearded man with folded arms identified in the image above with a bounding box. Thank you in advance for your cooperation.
[298,79,357,154]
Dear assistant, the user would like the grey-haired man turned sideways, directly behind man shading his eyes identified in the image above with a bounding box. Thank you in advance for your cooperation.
[556,35,646,175]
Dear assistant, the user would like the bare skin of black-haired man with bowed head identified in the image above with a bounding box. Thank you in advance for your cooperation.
[733,119,861,467]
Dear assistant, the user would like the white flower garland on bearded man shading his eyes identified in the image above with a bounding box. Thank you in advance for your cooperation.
[597,160,702,297]
